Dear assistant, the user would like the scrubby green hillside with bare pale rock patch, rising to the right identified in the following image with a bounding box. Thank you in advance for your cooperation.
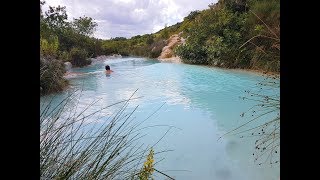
[102,0,280,72]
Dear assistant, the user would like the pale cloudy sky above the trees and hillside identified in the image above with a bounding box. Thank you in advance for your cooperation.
[43,0,217,39]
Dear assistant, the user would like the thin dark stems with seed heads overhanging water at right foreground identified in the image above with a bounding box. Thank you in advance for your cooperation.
[223,75,280,166]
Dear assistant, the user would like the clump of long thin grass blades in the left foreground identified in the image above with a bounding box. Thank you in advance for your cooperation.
[40,89,174,180]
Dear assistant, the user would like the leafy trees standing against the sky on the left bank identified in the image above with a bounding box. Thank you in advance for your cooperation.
[40,2,102,57]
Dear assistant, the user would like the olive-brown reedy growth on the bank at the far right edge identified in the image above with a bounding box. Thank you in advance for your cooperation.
[245,0,280,72]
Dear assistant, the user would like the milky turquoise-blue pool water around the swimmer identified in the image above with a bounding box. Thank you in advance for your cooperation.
[42,57,280,180]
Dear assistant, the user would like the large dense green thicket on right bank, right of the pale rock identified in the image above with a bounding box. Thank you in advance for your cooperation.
[176,0,280,72]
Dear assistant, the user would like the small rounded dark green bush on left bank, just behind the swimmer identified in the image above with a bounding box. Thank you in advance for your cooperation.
[70,48,91,67]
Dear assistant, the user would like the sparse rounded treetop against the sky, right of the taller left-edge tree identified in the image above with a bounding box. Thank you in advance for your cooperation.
[72,16,98,36]
